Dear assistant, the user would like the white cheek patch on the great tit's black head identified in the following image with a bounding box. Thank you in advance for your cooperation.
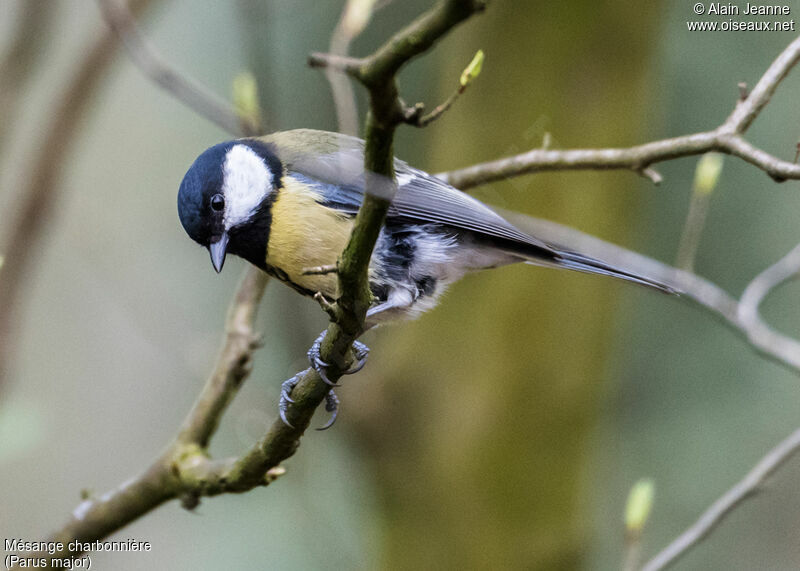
[222,145,272,230]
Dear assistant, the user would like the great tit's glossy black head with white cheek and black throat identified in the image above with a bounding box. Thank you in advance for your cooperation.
[178,139,283,272]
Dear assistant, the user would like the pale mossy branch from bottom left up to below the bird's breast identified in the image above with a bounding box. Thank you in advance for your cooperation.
[28,268,279,561]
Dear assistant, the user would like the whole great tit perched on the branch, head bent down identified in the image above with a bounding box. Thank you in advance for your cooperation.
[178,129,671,424]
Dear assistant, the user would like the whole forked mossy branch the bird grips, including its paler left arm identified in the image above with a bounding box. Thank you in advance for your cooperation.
[23,0,482,559]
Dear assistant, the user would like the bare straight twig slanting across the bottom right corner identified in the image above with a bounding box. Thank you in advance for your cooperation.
[642,429,800,571]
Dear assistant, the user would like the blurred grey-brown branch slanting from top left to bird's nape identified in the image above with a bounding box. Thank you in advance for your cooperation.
[97,0,248,135]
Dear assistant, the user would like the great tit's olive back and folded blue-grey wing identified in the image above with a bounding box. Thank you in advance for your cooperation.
[264,129,557,257]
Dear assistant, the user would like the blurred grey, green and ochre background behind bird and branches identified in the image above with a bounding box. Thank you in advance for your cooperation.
[0,0,800,570]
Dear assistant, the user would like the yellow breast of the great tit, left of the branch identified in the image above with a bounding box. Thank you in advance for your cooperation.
[267,177,353,299]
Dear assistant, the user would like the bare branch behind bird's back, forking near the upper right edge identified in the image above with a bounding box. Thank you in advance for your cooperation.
[438,38,800,190]
